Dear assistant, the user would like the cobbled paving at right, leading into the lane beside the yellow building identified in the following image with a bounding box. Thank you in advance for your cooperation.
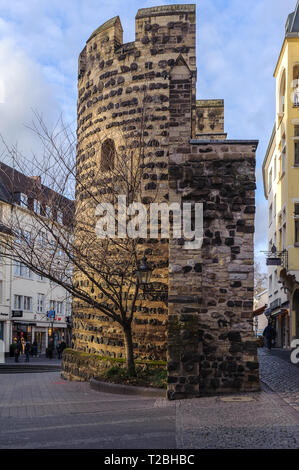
[170,348,299,449]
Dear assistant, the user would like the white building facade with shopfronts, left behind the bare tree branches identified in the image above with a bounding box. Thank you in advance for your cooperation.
[0,163,72,354]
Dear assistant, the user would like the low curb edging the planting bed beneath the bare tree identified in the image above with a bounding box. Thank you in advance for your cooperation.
[89,379,166,398]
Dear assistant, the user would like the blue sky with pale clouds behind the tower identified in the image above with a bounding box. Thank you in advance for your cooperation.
[0,0,296,264]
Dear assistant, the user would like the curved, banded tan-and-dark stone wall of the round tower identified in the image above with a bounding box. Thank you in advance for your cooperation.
[73,5,196,360]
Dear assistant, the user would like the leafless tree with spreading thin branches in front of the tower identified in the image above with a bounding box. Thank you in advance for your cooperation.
[0,104,162,375]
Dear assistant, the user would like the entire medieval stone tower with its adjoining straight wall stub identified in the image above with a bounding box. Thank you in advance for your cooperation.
[74,4,259,399]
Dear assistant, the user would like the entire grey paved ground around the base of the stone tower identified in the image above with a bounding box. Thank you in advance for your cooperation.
[0,350,299,449]
